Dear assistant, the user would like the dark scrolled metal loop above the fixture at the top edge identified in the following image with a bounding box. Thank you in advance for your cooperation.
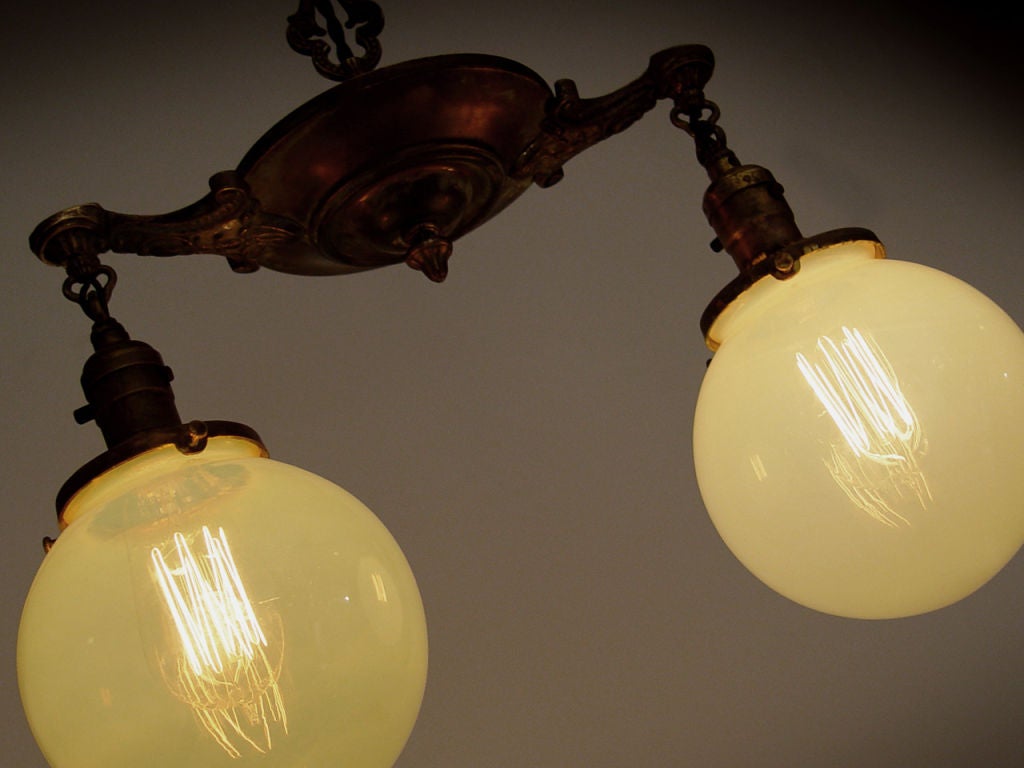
[287,0,384,82]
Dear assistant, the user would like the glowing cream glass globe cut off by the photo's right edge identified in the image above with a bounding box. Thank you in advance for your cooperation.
[693,243,1024,618]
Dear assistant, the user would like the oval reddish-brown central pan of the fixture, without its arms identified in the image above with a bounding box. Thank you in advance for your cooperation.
[238,54,552,274]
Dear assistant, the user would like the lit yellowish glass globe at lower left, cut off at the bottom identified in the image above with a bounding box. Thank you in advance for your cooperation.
[17,436,427,768]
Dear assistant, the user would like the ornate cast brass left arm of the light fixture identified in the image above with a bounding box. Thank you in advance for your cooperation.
[29,171,303,272]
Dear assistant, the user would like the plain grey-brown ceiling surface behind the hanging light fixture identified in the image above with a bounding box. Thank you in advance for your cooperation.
[0,0,1024,768]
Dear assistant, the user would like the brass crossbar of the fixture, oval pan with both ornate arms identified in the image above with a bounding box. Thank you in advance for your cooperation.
[30,45,714,281]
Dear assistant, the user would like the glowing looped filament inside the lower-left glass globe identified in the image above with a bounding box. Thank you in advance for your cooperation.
[150,525,288,757]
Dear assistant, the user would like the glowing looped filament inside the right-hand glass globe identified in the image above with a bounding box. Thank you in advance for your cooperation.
[797,328,931,526]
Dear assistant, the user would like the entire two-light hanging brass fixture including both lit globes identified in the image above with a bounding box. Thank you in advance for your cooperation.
[19,2,1024,768]
